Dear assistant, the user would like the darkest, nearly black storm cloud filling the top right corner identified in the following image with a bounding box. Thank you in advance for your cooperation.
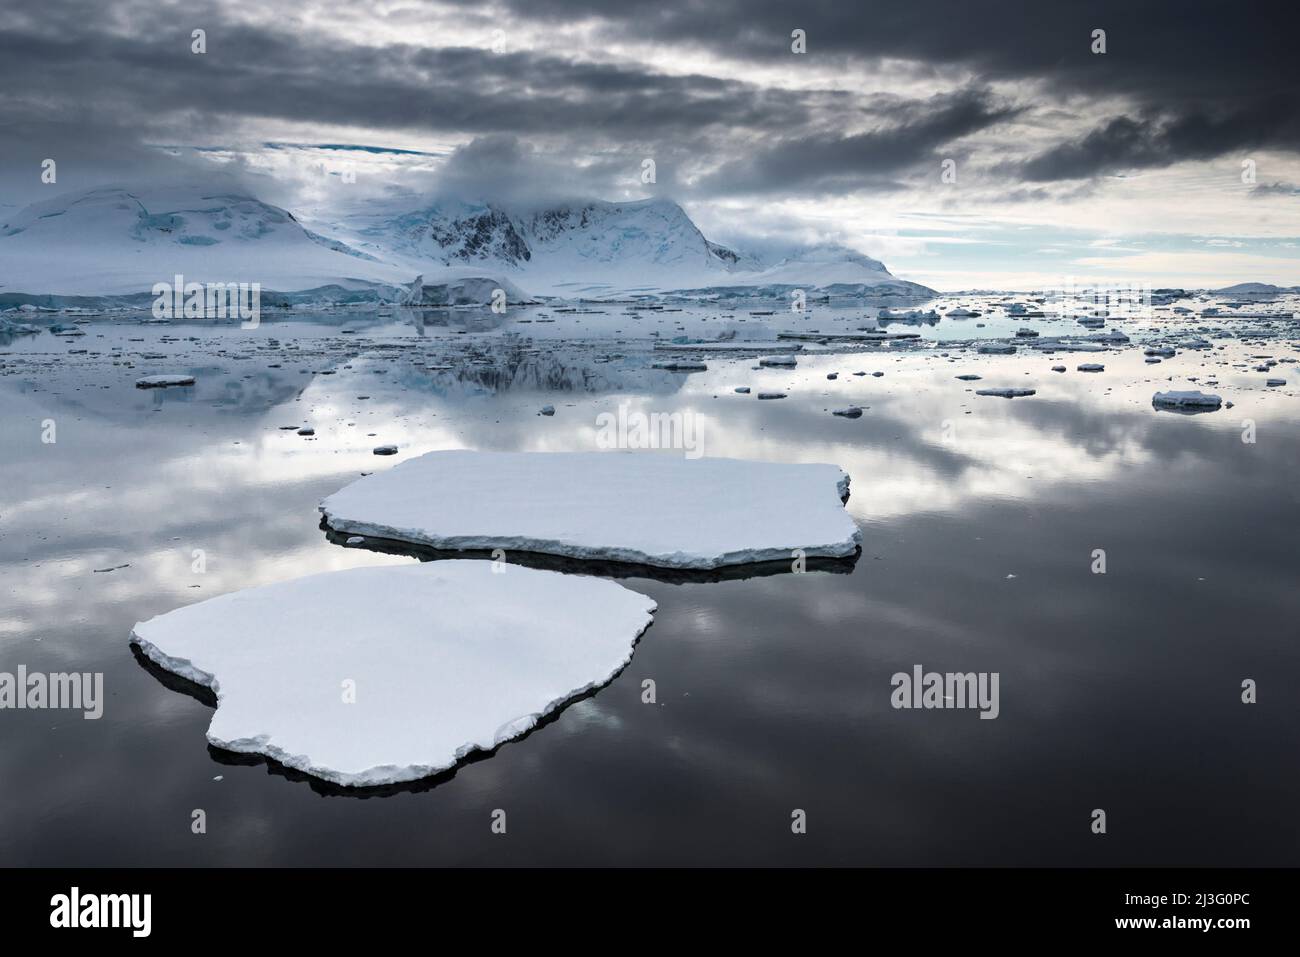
[454,0,1300,179]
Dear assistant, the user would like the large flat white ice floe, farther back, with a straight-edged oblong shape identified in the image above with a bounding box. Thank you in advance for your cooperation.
[320,450,861,568]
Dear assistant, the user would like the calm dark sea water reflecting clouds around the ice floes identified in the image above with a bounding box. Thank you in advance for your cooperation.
[0,300,1300,866]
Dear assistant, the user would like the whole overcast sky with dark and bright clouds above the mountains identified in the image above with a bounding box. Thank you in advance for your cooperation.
[0,0,1300,289]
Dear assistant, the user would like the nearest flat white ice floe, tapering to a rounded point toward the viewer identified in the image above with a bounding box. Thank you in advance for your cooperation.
[131,560,655,787]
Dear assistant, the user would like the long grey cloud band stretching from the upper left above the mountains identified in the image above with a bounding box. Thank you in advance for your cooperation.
[0,0,1000,192]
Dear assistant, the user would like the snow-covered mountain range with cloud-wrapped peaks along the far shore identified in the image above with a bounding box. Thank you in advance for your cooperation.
[0,183,932,302]
